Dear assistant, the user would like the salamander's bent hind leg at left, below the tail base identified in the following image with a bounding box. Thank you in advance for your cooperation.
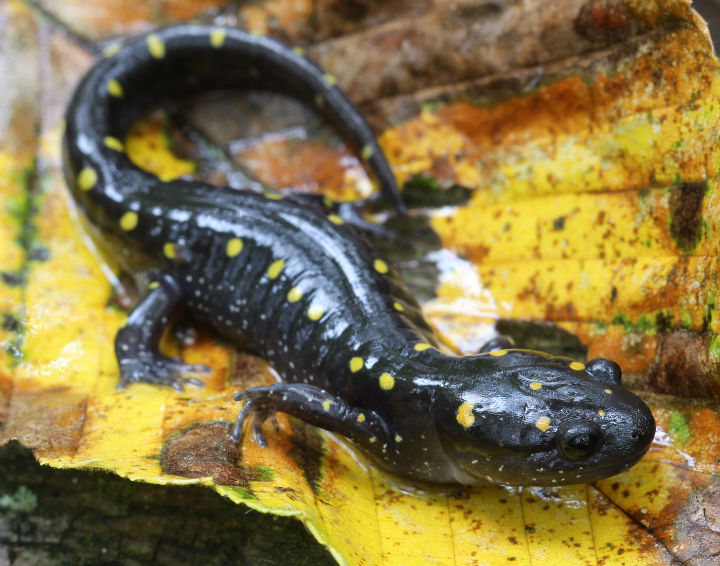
[115,276,209,391]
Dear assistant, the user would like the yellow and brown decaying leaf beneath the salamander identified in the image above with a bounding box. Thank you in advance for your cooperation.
[0,0,720,565]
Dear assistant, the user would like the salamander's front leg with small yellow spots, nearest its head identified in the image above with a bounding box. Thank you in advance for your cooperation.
[232,383,388,450]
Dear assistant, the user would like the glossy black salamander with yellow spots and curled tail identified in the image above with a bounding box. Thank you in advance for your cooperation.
[63,26,655,485]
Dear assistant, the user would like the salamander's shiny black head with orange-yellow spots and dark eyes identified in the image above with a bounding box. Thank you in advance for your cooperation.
[436,350,655,485]
